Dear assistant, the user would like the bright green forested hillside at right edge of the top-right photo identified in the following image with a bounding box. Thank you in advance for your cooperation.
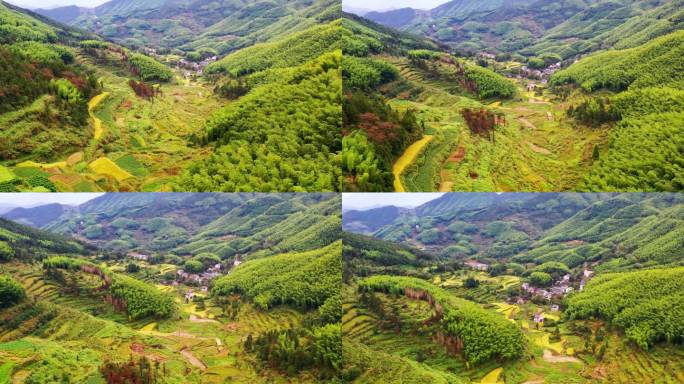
[551,31,684,191]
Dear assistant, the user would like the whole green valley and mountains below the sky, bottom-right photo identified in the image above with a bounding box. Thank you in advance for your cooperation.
[342,193,684,383]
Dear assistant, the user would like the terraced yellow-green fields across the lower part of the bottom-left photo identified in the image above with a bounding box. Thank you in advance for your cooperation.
[0,263,316,384]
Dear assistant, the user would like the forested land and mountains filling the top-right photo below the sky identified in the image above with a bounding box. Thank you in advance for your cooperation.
[342,0,683,192]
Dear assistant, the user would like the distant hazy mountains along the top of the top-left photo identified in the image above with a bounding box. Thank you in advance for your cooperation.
[37,0,335,54]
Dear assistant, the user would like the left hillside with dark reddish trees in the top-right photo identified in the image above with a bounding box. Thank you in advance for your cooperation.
[342,14,516,191]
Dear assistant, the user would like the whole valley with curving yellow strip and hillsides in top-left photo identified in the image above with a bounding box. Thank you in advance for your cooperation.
[0,0,341,192]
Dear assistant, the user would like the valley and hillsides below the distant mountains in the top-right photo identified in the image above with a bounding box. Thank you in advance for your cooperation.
[342,5,682,192]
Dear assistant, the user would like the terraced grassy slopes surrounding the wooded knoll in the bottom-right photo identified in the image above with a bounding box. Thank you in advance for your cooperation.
[342,273,684,383]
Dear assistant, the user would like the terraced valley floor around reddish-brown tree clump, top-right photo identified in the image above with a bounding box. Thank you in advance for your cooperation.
[382,57,607,192]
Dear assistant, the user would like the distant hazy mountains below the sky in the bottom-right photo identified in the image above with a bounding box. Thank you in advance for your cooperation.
[343,193,682,270]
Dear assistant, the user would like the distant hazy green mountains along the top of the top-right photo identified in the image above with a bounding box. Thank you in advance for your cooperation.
[365,0,682,58]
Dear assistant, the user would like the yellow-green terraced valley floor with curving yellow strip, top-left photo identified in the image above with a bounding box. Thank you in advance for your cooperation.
[0,55,221,192]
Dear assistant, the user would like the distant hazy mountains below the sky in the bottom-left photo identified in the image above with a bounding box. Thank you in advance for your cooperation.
[4,193,341,259]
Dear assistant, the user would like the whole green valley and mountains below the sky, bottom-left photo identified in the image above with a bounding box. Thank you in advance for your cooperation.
[0,193,342,384]
